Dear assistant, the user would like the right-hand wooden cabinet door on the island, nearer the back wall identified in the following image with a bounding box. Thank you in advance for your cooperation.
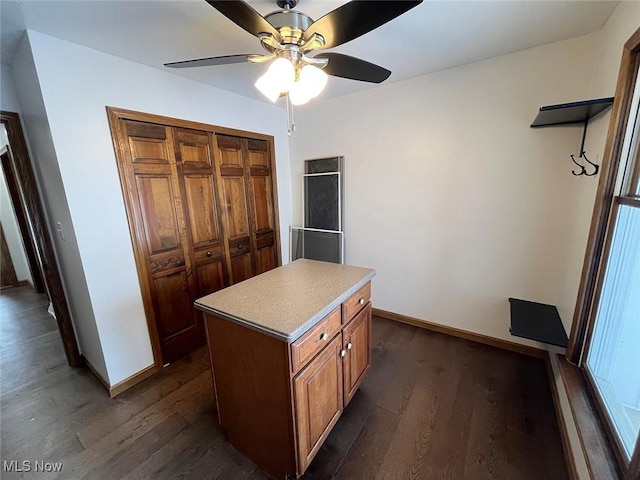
[342,303,371,407]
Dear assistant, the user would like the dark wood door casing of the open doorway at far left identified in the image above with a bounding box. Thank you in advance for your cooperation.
[0,110,84,367]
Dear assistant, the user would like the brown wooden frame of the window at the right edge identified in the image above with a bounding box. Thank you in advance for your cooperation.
[566,28,640,480]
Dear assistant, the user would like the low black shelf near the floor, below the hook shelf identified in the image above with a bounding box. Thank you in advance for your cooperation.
[509,298,569,348]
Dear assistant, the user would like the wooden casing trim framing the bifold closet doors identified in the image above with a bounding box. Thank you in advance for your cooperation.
[106,106,282,370]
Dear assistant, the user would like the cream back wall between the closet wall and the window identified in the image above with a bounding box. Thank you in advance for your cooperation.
[290,34,597,345]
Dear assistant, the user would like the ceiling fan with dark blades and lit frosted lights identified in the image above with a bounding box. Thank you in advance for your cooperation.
[165,0,422,105]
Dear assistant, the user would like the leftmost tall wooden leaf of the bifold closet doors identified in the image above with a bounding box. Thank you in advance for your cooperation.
[122,121,201,363]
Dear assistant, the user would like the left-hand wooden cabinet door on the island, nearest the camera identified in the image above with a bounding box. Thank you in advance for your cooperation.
[293,335,343,473]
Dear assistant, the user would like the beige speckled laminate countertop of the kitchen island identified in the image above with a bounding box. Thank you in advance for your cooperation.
[195,259,376,343]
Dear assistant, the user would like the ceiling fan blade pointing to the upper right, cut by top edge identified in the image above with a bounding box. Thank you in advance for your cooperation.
[304,0,422,48]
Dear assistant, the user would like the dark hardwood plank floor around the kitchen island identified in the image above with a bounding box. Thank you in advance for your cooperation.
[0,287,568,480]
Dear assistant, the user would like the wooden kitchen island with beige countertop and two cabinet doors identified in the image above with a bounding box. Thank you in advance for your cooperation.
[195,259,375,479]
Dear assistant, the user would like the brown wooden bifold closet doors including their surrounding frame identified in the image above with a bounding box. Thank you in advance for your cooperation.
[108,108,280,366]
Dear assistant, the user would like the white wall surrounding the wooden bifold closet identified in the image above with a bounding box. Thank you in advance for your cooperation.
[18,31,291,385]
